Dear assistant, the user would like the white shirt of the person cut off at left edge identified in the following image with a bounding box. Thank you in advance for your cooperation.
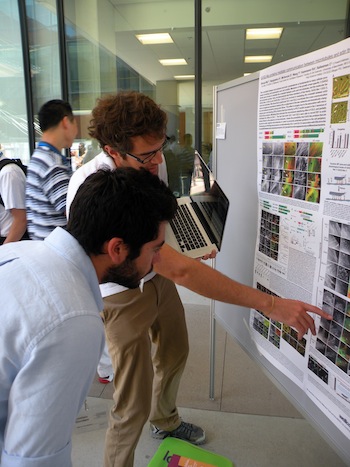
[0,154,26,237]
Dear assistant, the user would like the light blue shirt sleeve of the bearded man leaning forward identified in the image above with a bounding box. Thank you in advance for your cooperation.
[1,315,104,467]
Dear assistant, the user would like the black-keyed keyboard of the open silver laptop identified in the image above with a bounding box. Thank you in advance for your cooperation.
[170,204,207,251]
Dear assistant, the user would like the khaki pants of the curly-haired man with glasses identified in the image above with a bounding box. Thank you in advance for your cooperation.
[102,275,188,467]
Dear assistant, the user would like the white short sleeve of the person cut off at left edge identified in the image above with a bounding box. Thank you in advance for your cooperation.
[0,164,26,210]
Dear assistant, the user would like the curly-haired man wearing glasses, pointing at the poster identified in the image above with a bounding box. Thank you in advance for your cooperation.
[67,92,328,467]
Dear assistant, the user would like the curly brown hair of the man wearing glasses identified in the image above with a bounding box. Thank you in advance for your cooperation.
[89,91,167,154]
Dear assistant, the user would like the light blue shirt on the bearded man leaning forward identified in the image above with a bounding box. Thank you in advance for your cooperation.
[0,228,104,467]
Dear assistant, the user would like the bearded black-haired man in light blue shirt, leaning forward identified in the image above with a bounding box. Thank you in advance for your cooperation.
[0,168,177,467]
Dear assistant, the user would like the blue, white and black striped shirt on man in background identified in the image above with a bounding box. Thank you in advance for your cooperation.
[26,142,72,240]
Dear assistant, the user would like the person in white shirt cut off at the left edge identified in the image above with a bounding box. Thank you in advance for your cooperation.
[0,145,28,245]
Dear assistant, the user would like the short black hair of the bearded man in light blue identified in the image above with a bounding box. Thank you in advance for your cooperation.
[67,167,177,257]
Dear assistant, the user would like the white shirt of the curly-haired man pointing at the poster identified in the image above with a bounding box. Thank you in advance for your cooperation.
[67,152,168,297]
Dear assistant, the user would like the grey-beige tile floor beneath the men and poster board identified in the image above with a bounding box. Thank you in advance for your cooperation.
[72,288,350,467]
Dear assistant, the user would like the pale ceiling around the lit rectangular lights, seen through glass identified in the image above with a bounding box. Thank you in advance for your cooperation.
[109,0,348,84]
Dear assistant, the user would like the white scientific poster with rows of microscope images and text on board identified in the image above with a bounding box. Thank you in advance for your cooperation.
[250,39,350,440]
